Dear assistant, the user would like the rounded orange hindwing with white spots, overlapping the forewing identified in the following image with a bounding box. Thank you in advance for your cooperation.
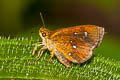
[51,36,92,63]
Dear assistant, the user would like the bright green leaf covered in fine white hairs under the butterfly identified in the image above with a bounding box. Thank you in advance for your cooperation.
[0,37,120,80]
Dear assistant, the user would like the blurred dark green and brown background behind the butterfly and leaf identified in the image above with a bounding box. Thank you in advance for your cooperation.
[0,0,120,60]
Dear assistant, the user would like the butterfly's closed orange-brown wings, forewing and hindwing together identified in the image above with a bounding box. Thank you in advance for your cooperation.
[50,25,104,63]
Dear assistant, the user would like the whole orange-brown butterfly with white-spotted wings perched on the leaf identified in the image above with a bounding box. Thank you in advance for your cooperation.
[32,12,104,67]
